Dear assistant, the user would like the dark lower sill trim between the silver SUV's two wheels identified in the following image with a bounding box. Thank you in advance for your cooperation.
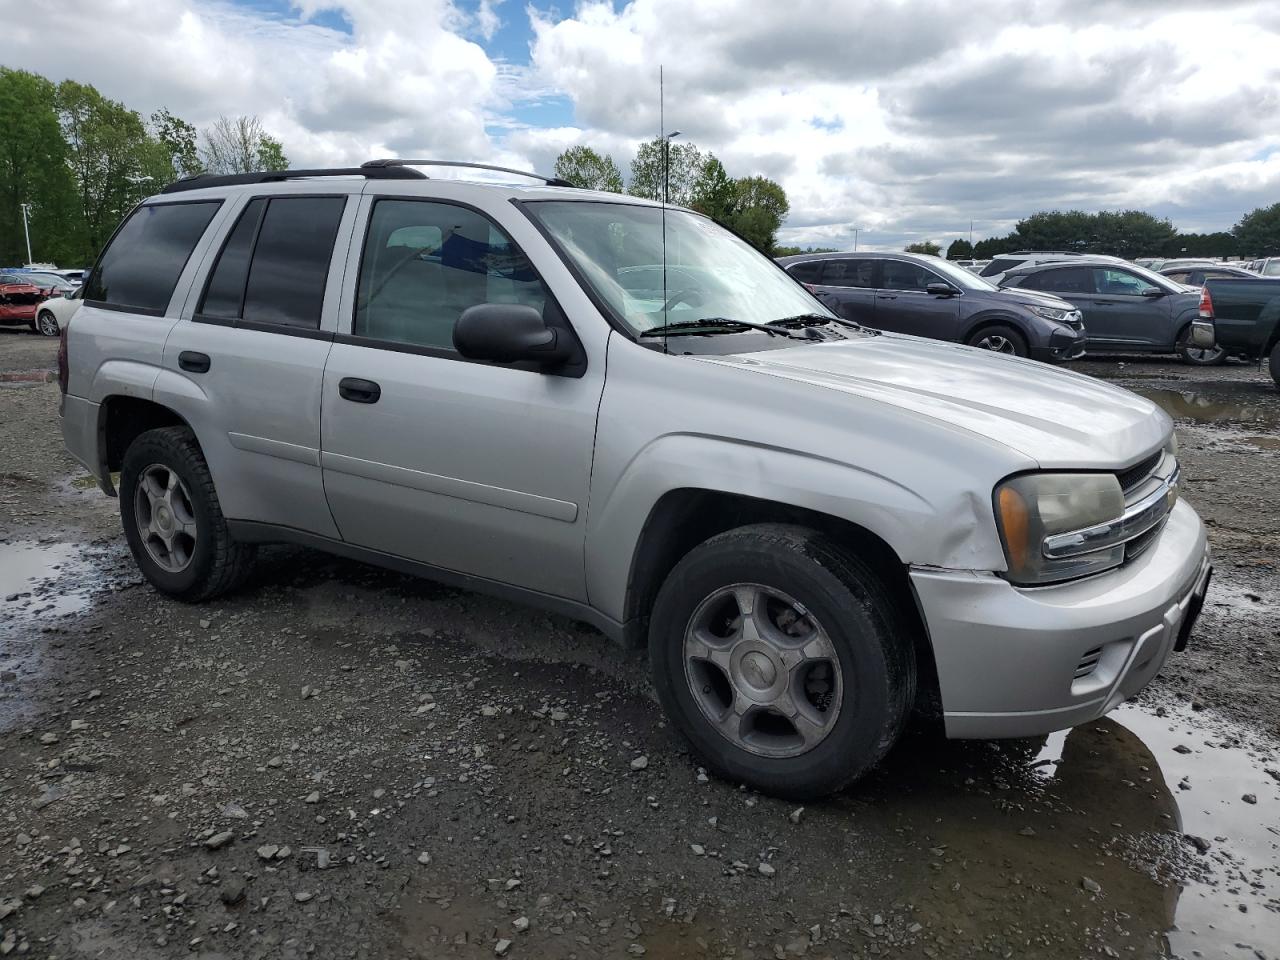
[227,520,622,641]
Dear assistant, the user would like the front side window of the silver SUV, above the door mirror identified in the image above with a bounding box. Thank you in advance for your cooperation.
[353,200,545,351]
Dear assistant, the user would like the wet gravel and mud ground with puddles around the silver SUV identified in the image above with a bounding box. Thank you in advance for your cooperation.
[0,338,1280,959]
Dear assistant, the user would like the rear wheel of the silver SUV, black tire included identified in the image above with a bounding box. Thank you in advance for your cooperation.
[120,426,256,603]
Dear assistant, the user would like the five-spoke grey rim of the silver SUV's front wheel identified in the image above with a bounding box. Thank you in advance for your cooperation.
[684,584,844,758]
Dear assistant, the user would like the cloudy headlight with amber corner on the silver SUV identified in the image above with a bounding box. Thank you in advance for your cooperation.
[995,474,1125,586]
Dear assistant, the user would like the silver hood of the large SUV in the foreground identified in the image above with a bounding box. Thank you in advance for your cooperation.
[700,334,1172,470]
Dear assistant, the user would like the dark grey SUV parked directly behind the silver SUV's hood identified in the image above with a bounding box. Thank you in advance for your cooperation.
[778,253,1085,361]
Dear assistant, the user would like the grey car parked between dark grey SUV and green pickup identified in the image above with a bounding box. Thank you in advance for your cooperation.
[1004,259,1226,366]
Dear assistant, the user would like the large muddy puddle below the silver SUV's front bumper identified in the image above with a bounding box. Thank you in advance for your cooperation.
[839,705,1280,957]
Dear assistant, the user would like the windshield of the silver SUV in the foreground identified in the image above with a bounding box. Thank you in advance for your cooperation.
[526,200,832,335]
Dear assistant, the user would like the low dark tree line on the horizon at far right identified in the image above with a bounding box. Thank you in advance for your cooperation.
[931,204,1280,260]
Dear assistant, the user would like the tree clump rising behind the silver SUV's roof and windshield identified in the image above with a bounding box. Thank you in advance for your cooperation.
[556,144,791,256]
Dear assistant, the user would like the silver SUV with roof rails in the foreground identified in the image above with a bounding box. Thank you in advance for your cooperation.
[60,161,1210,797]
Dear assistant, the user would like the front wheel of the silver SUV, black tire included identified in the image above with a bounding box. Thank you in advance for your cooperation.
[649,524,916,800]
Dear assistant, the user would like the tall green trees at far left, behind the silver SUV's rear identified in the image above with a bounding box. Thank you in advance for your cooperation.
[0,67,288,266]
